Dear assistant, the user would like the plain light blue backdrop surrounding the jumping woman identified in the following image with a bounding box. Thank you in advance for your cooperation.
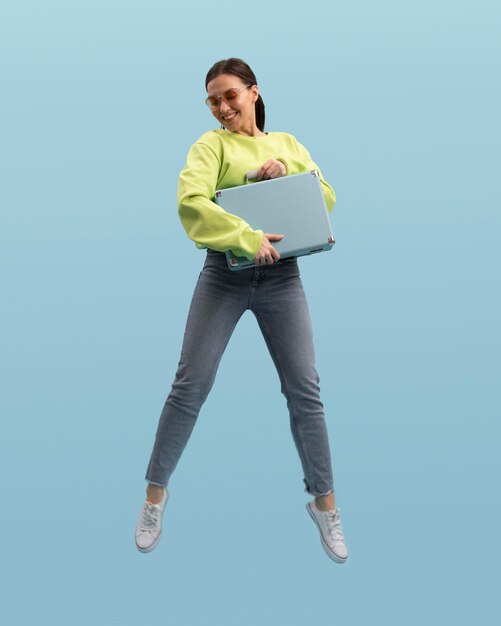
[0,0,501,626]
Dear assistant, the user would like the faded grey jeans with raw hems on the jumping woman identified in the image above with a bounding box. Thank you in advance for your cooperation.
[146,250,333,496]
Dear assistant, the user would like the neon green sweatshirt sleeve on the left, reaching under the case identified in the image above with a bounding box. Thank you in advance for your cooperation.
[177,142,263,260]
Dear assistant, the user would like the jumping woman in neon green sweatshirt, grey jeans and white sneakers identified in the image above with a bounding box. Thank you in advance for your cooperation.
[136,58,348,563]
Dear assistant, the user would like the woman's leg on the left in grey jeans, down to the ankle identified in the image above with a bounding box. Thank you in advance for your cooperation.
[146,254,247,488]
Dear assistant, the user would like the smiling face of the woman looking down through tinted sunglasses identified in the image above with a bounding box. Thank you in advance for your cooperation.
[207,74,263,136]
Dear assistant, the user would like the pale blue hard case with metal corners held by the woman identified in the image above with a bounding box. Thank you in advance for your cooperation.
[214,170,335,270]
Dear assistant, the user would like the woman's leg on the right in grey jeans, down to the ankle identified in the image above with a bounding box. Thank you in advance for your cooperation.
[251,260,334,498]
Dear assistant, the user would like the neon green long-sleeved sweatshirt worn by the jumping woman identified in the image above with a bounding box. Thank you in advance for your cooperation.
[177,129,336,260]
